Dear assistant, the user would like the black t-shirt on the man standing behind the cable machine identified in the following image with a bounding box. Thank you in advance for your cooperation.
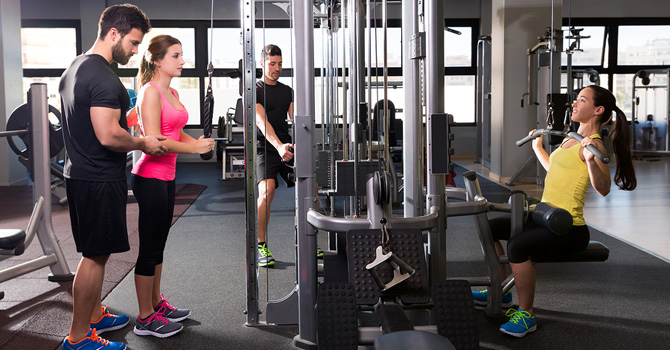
[256,81,293,153]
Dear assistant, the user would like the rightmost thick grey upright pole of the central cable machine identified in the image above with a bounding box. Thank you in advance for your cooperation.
[425,0,446,283]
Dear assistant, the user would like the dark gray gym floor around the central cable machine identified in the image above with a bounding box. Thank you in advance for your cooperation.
[94,164,670,349]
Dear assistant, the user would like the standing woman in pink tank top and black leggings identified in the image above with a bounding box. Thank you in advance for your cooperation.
[131,35,214,338]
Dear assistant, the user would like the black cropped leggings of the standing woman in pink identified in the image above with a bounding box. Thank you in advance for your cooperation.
[130,174,175,276]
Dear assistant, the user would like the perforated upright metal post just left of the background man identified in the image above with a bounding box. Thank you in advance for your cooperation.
[240,0,259,326]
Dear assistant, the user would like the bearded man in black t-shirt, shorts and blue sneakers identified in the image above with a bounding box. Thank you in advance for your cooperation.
[59,4,167,350]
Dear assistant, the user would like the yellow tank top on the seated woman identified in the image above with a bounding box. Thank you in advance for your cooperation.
[542,134,600,226]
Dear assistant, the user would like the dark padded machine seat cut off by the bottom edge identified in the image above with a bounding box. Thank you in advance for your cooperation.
[375,331,456,350]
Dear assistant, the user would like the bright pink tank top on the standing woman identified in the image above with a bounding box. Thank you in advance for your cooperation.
[132,82,188,181]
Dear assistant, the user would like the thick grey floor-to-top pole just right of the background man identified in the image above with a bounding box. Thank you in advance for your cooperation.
[293,0,317,349]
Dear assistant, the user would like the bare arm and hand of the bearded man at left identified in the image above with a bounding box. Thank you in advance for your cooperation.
[91,107,167,155]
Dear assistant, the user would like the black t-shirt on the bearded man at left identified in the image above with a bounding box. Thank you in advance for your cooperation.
[59,54,130,181]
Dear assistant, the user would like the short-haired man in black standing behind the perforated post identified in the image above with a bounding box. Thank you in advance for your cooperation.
[256,45,295,266]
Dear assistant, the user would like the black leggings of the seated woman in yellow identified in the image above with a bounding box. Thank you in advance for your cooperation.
[489,215,590,264]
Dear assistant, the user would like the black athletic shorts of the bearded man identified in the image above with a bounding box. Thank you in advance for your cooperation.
[65,179,130,257]
